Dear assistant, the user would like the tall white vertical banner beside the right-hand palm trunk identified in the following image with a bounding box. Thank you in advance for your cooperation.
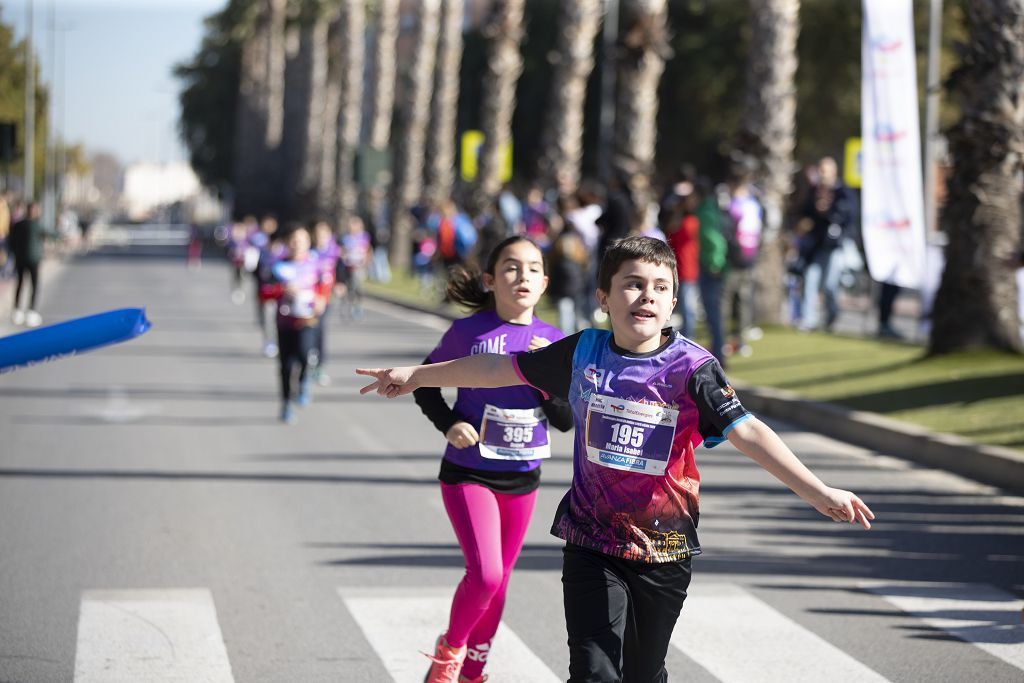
[860,0,925,289]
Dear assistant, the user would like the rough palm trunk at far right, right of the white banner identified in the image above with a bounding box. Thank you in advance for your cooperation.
[930,0,1024,353]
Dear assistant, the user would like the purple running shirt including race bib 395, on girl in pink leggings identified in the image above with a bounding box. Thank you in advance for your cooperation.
[416,309,564,472]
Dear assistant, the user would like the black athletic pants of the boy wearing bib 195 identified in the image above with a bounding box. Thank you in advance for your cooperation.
[562,544,690,683]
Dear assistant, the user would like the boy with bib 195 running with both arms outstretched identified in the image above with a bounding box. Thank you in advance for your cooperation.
[356,237,874,682]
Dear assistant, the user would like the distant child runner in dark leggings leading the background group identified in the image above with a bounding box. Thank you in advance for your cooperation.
[260,226,334,424]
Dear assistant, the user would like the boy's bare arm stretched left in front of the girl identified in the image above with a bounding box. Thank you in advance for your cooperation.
[355,353,523,398]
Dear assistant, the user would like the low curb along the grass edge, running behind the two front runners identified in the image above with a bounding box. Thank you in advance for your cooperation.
[367,292,1024,494]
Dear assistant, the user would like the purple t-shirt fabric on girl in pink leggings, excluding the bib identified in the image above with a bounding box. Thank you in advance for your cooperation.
[427,310,565,472]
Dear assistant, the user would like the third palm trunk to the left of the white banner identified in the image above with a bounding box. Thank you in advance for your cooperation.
[539,0,601,197]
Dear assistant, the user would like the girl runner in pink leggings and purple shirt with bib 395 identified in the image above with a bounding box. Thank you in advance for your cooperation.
[414,236,572,683]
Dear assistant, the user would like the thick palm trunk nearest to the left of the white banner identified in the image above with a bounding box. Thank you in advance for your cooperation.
[734,0,800,323]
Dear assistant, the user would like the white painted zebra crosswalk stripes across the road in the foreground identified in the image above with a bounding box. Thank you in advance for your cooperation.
[66,582,1024,683]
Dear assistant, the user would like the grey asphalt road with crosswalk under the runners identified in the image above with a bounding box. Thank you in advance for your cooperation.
[0,236,1024,683]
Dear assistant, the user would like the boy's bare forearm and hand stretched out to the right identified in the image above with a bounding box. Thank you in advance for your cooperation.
[728,417,874,528]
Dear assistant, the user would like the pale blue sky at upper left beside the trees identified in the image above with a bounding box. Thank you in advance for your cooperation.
[7,0,227,163]
